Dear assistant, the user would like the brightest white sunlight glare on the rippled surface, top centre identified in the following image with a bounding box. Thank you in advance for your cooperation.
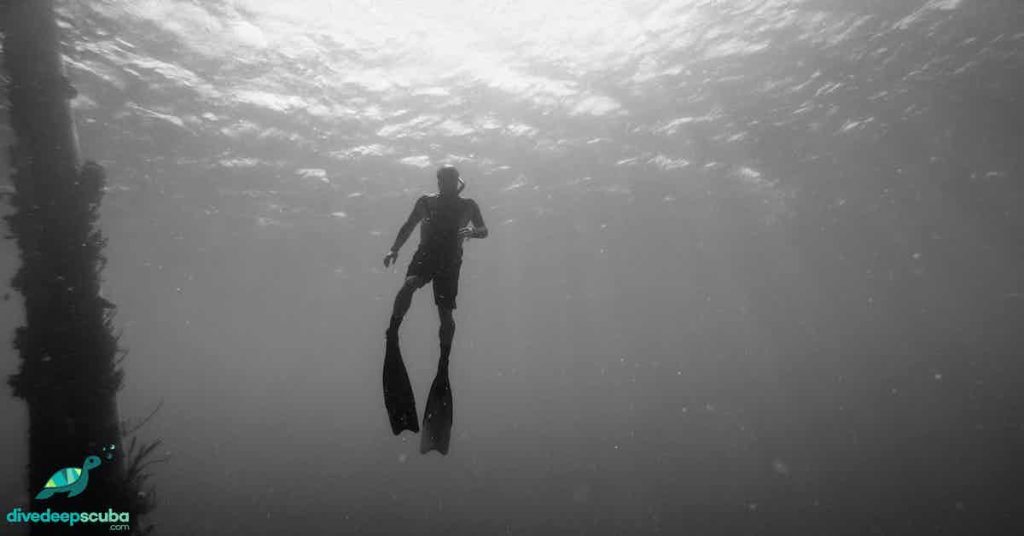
[90,0,695,116]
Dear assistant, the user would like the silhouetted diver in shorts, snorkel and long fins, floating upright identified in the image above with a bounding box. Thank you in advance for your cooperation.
[384,165,487,454]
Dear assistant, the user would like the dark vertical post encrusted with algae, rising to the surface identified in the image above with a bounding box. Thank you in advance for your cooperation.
[0,0,151,534]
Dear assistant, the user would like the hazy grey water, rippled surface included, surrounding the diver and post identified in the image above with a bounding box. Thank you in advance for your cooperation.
[0,0,1024,535]
